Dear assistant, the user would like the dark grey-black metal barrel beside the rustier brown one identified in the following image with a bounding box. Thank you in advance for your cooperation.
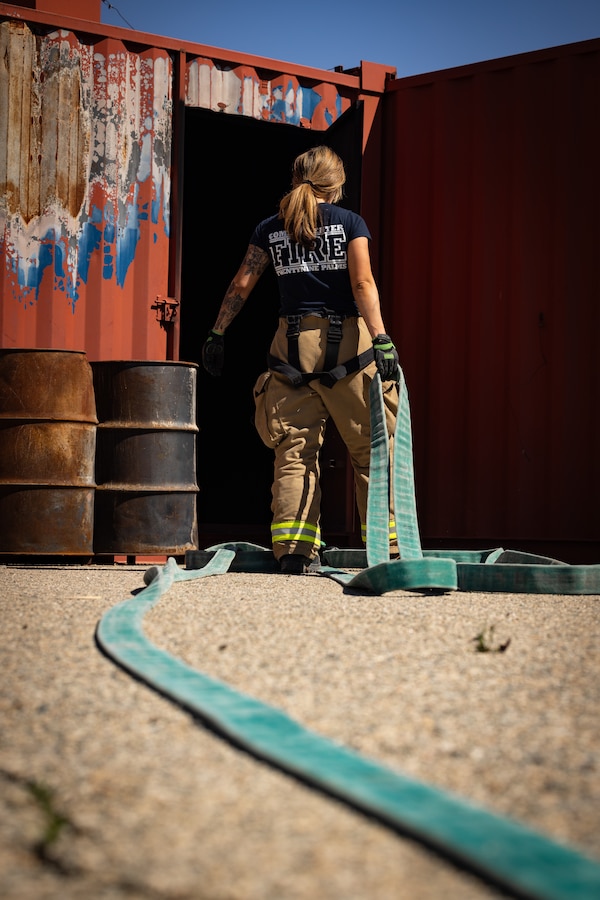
[91,360,198,556]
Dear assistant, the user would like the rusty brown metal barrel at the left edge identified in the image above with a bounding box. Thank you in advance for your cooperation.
[0,349,97,556]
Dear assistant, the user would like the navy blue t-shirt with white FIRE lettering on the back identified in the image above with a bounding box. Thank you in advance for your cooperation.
[250,203,371,316]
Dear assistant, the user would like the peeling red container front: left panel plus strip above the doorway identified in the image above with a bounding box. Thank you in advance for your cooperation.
[0,0,368,359]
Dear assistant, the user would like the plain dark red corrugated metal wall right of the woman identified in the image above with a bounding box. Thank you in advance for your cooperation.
[381,41,600,562]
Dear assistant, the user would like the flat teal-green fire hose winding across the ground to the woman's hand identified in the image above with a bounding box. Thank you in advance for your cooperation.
[97,373,600,900]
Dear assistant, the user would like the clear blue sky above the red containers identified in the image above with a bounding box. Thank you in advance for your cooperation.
[101,0,600,77]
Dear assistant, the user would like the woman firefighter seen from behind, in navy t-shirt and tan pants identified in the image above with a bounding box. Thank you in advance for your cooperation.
[202,146,398,574]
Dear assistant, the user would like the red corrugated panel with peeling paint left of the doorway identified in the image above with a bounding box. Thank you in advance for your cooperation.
[0,21,172,359]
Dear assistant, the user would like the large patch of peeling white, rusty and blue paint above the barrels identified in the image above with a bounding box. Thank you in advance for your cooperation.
[0,21,172,311]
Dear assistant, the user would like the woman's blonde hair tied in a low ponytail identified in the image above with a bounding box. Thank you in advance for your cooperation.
[279,146,346,247]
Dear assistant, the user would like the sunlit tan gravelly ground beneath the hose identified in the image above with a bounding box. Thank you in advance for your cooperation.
[0,565,600,900]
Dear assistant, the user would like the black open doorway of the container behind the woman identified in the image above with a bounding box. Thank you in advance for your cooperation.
[180,103,360,547]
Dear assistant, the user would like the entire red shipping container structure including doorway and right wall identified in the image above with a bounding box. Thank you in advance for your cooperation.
[0,0,600,562]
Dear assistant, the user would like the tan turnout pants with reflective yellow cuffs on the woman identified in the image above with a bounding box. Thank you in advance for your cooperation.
[254,316,398,559]
